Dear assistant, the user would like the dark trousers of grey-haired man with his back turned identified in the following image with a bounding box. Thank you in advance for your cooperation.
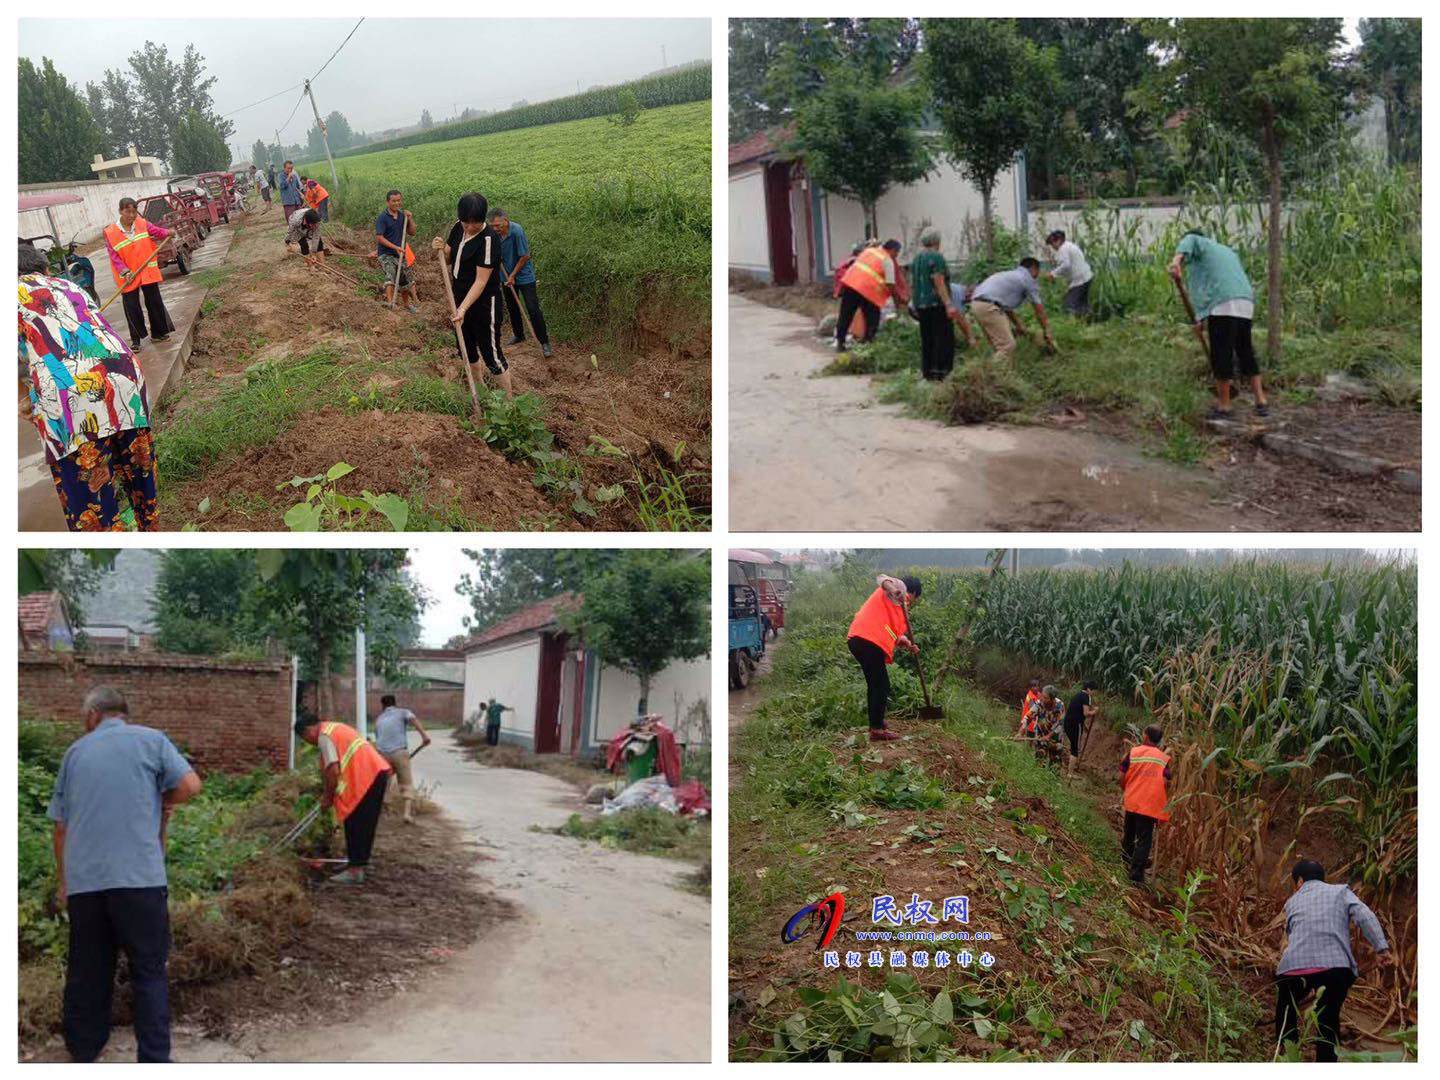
[63,886,170,1061]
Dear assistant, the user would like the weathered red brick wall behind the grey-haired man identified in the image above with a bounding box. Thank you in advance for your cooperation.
[19,652,291,775]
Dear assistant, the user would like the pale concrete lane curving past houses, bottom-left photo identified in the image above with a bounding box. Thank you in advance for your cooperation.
[90,734,711,1061]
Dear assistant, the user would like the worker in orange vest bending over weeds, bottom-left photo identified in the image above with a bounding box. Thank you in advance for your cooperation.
[295,713,395,886]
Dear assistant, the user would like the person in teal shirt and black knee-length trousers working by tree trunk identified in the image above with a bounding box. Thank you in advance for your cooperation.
[1169,229,1270,420]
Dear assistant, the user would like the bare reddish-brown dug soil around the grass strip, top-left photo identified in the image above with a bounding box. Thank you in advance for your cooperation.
[168,215,711,528]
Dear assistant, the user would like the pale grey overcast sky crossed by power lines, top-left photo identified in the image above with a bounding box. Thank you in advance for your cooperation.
[20,16,710,158]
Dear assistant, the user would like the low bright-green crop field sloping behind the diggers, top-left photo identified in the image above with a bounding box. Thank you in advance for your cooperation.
[301,101,710,353]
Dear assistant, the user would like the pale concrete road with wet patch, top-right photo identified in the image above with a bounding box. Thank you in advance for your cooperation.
[730,294,1255,533]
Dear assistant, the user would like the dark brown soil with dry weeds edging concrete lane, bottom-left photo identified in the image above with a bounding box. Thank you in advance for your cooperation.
[20,778,516,1061]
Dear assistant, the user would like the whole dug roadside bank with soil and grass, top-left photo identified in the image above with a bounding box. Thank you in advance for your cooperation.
[156,213,710,530]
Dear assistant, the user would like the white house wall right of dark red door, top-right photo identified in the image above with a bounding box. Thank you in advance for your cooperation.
[824,163,1020,275]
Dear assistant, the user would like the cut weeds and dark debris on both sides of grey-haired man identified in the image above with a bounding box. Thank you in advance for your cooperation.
[19,721,511,1060]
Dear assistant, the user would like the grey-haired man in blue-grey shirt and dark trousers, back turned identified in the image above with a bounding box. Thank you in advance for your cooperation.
[49,687,200,1061]
